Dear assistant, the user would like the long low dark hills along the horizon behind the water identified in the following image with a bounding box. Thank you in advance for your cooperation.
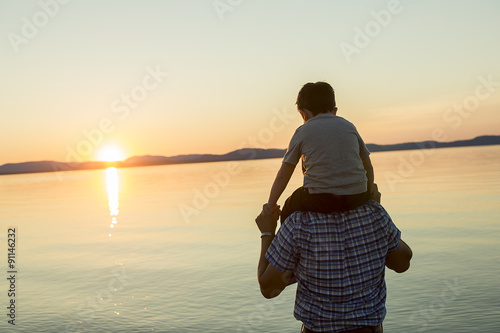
[0,135,500,175]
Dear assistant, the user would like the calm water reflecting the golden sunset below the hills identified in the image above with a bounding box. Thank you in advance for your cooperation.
[0,146,500,333]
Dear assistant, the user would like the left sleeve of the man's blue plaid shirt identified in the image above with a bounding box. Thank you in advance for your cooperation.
[266,219,297,273]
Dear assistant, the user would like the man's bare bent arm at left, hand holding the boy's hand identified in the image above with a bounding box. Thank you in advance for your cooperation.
[255,204,292,298]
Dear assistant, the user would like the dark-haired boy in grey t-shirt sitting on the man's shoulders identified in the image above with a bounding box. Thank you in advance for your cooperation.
[268,82,374,223]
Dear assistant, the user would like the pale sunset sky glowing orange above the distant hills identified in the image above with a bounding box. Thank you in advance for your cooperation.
[0,0,500,165]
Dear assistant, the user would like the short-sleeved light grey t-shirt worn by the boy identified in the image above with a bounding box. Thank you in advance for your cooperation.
[283,113,370,195]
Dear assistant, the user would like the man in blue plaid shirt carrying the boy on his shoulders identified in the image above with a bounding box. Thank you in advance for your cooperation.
[256,184,412,333]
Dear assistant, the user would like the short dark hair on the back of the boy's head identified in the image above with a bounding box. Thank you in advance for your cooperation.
[296,82,336,116]
